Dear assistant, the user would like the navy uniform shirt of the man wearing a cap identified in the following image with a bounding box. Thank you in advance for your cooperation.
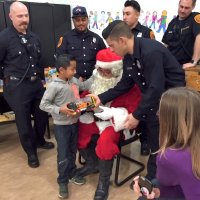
[56,29,106,79]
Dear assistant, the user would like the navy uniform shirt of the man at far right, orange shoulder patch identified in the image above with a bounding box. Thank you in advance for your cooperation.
[162,12,200,65]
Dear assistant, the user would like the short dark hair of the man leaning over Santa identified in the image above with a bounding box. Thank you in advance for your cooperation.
[102,20,133,40]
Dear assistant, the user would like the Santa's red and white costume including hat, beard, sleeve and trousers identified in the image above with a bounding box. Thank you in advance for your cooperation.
[78,48,141,160]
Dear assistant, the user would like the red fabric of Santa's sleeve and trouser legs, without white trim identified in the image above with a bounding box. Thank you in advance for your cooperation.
[78,85,141,160]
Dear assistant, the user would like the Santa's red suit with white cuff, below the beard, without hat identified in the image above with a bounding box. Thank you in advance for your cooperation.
[78,85,141,160]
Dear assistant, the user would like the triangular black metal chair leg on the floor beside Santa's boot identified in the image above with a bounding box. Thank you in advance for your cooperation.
[115,153,145,186]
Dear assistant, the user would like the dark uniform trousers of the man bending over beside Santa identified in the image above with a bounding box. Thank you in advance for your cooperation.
[146,114,159,179]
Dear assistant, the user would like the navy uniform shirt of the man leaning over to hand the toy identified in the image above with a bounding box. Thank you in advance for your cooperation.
[99,37,185,120]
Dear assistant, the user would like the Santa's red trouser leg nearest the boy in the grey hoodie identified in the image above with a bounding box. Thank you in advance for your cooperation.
[78,121,99,149]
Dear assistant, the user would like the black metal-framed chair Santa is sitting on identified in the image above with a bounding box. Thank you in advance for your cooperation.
[114,132,145,186]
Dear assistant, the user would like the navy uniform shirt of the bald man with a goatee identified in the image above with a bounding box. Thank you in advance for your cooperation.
[0,26,44,78]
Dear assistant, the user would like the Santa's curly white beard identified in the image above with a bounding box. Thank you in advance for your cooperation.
[90,70,122,95]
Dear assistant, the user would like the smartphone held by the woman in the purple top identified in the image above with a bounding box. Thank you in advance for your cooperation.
[138,176,153,196]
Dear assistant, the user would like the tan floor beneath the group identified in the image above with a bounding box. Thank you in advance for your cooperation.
[0,120,147,200]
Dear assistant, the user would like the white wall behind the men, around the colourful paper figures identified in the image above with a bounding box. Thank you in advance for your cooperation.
[22,0,200,40]
